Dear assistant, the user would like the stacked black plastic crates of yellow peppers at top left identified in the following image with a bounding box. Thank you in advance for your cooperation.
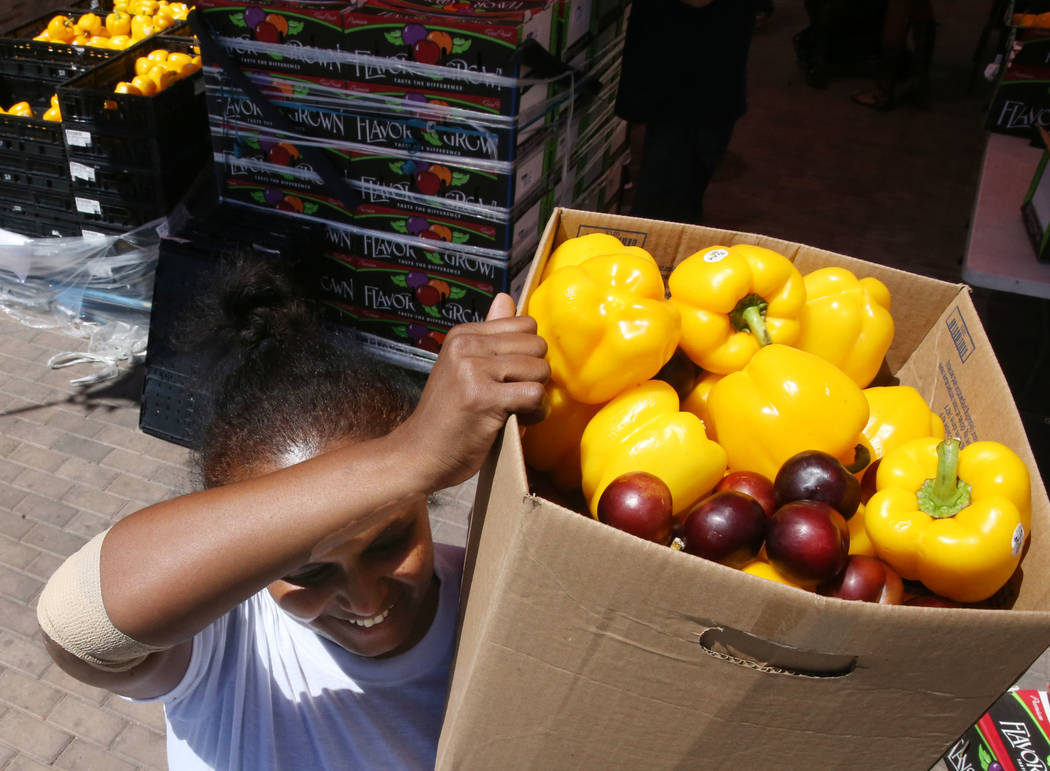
[0,0,208,236]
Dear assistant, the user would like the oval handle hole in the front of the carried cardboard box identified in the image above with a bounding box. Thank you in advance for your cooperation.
[697,626,857,678]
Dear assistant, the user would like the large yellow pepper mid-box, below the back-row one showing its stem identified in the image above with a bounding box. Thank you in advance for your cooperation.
[708,343,867,479]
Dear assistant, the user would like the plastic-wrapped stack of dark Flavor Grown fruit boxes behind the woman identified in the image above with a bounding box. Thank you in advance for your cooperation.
[200,0,626,369]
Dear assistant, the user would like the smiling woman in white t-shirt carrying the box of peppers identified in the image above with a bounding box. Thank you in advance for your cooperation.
[38,262,549,771]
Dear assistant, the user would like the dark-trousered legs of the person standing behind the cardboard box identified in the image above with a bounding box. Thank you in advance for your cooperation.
[631,119,736,224]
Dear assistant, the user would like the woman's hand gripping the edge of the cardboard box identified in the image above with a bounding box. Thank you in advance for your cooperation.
[395,294,550,489]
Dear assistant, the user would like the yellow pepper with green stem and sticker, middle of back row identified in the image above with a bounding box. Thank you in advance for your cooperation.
[668,244,805,375]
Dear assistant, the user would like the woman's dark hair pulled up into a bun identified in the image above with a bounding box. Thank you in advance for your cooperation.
[184,255,419,487]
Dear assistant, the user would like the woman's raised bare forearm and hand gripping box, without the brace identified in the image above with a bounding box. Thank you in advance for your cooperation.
[40,295,549,692]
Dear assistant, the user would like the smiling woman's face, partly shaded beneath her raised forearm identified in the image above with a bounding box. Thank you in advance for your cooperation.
[246,445,439,658]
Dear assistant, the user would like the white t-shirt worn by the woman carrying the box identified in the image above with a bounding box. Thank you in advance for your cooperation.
[139,544,463,771]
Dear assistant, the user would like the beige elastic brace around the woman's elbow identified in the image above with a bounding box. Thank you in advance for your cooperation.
[37,530,164,672]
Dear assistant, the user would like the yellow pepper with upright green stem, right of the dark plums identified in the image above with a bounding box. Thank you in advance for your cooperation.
[864,437,1031,602]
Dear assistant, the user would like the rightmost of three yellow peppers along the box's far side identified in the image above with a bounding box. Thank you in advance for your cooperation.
[794,268,894,388]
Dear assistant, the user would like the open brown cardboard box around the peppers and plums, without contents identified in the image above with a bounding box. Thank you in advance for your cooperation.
[437,208,1050,771]
